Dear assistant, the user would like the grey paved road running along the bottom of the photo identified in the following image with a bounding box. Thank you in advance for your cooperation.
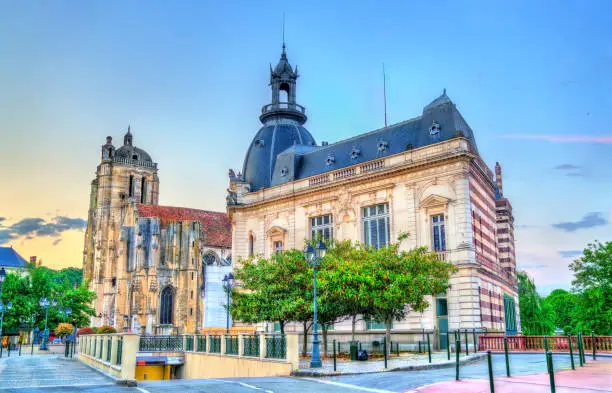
[0,354,611,393]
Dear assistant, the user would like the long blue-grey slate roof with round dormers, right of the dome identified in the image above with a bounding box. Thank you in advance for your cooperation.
[266,91,477,186]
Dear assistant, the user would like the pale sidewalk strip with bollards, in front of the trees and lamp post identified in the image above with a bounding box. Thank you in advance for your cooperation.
[293,352,486,377]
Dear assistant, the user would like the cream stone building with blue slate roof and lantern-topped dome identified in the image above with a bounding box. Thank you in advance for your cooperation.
[227,45,520,344]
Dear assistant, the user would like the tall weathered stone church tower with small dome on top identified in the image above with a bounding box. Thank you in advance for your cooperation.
[83,127,159,325]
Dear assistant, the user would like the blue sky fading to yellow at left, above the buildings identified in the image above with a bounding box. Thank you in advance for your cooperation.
[0,0,612,292]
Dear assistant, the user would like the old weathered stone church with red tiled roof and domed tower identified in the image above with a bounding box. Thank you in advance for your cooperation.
[83,127,232,334]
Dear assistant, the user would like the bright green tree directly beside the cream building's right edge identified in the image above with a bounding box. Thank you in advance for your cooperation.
[517,271,555,335]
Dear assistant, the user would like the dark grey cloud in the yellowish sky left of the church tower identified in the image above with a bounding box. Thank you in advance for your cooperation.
[0,216,87,245]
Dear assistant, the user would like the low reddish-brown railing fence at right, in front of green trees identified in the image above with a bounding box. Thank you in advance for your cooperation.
[478,335,612,352]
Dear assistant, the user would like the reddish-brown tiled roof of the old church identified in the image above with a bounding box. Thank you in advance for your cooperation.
[136,204,232,248]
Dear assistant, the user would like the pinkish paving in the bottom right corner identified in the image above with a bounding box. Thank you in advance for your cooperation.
[406,359,612,393]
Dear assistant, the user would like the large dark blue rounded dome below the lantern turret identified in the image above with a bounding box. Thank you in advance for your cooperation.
[242,119,316,191]
